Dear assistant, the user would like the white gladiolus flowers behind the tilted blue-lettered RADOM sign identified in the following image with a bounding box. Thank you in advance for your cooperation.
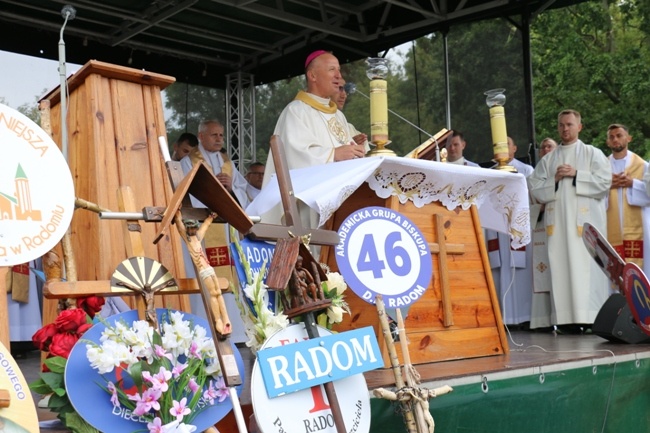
[231,230,350,353]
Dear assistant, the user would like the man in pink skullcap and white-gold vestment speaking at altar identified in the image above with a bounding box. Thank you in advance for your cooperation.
[264,50,367,227]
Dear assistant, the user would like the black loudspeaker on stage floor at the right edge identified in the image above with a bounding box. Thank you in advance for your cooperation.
[591,293,650,344]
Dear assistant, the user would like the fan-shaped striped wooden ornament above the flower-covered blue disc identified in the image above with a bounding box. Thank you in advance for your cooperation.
[111,257,178,292]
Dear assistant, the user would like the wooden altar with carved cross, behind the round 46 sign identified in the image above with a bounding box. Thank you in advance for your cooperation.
[321,183,509,367]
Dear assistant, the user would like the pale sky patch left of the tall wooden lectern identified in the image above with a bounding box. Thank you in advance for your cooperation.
[0,51,81,108]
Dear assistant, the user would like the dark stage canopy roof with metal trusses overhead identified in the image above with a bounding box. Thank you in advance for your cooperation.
[0,0,583,88]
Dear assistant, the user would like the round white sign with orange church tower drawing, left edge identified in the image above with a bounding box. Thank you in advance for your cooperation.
[0,104,74,266]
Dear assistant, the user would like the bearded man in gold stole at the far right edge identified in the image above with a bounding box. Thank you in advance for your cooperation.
[607,123,650,275]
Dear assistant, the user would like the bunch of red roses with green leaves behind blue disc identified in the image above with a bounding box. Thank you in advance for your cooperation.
[29,296,104,433]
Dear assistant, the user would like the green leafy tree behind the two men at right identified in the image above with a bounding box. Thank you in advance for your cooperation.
[531,0,650,156]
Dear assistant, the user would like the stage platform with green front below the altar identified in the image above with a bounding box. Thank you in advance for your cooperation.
[17,331,650,433]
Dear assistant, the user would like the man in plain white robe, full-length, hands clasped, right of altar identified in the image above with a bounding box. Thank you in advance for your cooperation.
[528,110,612,329]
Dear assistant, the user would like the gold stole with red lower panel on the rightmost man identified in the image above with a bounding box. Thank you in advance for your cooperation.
[607,154,645,267]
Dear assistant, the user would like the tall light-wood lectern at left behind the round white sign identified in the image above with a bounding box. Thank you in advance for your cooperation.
[44,60,189,311]
